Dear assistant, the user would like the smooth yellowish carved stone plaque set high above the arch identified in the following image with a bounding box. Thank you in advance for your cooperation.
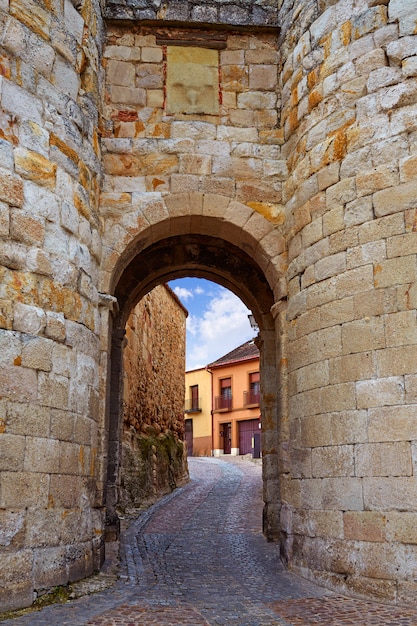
[166,46,219,115]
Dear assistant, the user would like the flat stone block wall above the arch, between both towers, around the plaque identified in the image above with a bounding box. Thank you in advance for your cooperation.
[101,23,287,258]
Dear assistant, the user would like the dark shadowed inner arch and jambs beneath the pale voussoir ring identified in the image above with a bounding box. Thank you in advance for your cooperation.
[106,233,279,540]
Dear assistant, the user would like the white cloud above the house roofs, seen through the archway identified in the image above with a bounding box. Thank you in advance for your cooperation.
[187,288,254,370]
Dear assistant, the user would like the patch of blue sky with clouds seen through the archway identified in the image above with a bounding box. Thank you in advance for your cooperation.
[169,278,257,371]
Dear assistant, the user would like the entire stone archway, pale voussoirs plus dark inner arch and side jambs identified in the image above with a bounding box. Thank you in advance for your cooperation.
[102,193,285,538]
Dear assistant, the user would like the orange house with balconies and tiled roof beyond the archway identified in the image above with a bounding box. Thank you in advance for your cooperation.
[207,340,261,456]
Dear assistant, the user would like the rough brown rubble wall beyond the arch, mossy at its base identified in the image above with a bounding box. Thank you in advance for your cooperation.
[119,285,188,509]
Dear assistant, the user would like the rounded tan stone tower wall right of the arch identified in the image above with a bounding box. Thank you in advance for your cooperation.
[280,0,417,603]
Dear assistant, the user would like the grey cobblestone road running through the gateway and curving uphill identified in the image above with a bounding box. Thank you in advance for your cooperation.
[2,458,417,626]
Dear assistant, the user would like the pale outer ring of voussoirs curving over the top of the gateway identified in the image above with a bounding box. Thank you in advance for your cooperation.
[100,192,286,300]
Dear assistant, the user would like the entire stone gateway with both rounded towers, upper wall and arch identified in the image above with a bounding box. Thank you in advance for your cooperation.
[0,0,417,610]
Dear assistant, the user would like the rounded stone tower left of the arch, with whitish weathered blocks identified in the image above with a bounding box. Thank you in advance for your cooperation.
[0,0,103,609]
